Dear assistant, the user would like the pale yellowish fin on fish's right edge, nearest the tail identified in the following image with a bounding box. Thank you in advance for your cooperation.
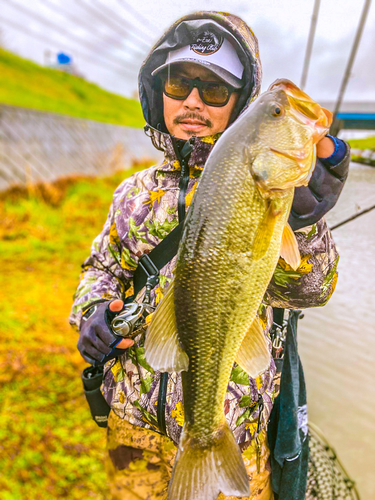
[236,317,271,378]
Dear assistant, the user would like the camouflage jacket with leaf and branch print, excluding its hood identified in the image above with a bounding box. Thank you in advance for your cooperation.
[70,134,338,443]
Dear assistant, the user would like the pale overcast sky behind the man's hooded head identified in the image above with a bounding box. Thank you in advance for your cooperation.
[0,0,375,101]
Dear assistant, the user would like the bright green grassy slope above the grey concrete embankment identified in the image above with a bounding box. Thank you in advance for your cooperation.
[0,48,144,127]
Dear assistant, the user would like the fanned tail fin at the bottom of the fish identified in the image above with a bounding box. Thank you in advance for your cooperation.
[168,421,250,500]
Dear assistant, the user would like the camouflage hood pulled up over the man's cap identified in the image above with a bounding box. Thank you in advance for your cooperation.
[138,11,262,151]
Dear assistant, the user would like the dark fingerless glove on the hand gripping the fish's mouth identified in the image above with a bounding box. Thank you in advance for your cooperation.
[289,143,350,231]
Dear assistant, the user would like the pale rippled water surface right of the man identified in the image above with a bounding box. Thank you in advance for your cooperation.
[299,163,375,500]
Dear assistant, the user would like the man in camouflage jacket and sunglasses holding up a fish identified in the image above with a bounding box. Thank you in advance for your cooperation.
[71,12,349,499]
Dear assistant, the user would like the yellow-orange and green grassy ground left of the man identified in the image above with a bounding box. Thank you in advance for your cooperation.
[0,167,145,500]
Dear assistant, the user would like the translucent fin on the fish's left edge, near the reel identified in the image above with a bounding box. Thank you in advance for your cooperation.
[145,281,189,372]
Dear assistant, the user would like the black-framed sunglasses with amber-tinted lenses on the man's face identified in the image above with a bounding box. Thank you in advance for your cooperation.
[161,75,237,107]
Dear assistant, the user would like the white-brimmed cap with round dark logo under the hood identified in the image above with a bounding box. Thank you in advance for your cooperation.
[151,30,244,88]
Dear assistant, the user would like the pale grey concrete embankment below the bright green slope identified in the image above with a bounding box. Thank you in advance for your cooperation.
[0,105,160,190]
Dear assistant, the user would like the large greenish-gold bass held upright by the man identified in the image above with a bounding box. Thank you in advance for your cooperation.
[145,79,332,500]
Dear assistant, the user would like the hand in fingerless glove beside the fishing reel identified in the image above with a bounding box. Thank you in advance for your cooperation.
[77,300,134,366]
